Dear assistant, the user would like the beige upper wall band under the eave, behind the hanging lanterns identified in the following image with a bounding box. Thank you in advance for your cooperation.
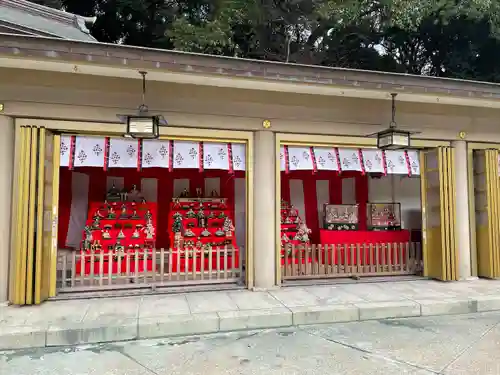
[0,69,500,142]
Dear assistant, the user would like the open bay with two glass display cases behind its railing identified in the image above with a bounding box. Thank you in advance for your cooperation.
[280,146,423,281]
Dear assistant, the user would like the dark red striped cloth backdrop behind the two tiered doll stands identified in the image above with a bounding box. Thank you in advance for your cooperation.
[58,167,245,248]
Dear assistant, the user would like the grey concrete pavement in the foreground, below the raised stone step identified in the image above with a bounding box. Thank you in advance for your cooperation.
[0,312,500,375]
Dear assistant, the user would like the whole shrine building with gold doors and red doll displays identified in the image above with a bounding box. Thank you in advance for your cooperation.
[0,0,500,305]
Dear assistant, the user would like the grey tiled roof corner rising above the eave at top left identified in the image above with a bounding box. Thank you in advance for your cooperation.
[0,0,95,41]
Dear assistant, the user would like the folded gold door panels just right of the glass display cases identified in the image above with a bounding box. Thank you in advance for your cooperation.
[421,147,457,280]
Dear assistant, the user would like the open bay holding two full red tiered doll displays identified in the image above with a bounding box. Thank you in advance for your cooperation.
[57,136,247,293]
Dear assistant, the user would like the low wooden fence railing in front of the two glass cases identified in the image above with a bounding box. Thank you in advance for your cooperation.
[281,242,423,281]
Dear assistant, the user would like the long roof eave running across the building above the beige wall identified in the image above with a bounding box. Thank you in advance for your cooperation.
[0,35,500,107]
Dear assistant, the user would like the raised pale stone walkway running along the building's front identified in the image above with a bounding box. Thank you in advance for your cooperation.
[0,280,500,349]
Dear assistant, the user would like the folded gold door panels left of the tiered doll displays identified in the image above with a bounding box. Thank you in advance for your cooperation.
[10,126,59,305]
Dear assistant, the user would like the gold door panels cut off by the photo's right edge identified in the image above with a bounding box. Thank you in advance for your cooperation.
[473,150,500,278]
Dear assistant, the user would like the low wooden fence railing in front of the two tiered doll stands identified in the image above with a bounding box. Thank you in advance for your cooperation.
[57,246,243,292]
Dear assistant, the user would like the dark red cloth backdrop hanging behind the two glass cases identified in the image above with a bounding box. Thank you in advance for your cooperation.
[281,171,369,243]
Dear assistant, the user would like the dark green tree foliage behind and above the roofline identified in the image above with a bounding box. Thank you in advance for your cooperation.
[30,0,500,82]
